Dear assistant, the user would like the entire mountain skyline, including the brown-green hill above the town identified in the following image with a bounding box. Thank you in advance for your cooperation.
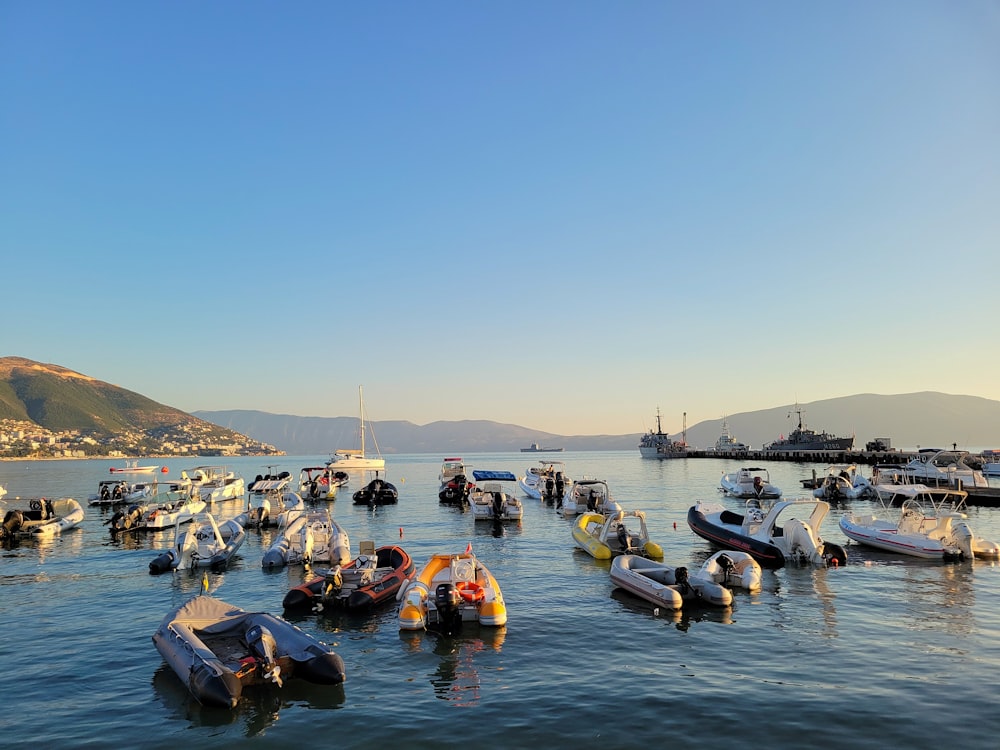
[0,357,1000,456]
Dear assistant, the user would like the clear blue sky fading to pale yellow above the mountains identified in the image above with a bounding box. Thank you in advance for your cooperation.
[0,0,1000,434]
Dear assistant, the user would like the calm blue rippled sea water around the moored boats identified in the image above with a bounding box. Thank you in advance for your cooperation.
[0,451,1000,748]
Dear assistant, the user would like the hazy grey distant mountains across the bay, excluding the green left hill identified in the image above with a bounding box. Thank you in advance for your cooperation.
[194,392,1000,456]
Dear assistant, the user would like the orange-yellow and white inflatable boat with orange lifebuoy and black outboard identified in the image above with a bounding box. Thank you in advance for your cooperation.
[399,550,507,635]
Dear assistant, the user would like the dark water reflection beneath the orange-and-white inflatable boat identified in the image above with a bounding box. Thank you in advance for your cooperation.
[399,627,507,707]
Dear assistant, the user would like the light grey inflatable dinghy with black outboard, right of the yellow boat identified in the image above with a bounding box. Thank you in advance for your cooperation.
[610,555,733,609]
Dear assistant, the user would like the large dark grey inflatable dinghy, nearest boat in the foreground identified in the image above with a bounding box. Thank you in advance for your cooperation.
[153,596,345,708]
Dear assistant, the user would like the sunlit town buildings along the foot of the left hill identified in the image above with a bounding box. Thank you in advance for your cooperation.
[0,419,284,458]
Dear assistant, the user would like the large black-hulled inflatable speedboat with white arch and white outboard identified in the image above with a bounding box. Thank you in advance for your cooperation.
[687,498,847,568]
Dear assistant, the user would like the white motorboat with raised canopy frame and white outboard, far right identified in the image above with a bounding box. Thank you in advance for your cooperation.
[840,484,1000,561]
